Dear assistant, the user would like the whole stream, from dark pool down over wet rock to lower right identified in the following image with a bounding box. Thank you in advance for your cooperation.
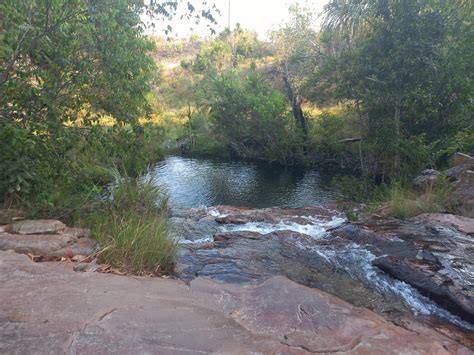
[148,156,474,333]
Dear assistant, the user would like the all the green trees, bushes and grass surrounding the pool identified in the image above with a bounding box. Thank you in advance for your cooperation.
[0,0,474,271]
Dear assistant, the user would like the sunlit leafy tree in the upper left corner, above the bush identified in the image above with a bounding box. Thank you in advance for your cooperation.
[0,0,218,200]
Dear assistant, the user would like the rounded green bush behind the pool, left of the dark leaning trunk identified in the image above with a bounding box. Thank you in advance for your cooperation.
[208,70,302,164]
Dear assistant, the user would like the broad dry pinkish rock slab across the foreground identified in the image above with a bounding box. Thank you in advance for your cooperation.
[0,252,470,354]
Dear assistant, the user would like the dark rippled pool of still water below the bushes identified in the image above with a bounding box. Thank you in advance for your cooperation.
[150,156,338,208]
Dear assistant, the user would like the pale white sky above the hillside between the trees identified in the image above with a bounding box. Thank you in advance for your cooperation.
[147,0,329,38]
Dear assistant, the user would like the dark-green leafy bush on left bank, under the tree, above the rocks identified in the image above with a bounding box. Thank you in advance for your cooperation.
[0,123,163,222]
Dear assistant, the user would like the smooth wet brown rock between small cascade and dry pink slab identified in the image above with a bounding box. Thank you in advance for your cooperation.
[175,231,420,326]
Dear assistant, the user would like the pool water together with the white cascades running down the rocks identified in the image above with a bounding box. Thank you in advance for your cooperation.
[149,156,474,330]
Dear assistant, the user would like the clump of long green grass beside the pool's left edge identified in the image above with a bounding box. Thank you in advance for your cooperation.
[83,170,179,274]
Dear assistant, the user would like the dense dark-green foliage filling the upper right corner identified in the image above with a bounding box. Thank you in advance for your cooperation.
[320,0,474,181]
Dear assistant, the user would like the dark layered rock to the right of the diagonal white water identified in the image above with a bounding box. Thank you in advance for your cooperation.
[331,218,474,323]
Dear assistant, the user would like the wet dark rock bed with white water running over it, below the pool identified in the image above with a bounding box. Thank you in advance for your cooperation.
[173,206,474,346]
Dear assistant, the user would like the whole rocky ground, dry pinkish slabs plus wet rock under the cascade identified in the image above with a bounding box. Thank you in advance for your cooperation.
[0,206,474,354]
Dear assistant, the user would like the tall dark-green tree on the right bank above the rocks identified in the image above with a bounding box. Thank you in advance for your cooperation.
[325,0,472,179]
